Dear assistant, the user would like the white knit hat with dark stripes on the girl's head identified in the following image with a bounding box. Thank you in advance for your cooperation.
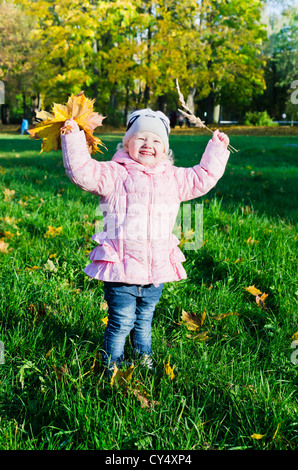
[122,108,170,152]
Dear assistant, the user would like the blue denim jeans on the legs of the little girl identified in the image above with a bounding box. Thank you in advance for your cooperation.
[103,282,163,366]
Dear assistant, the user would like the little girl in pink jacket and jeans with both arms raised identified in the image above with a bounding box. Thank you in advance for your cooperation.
[61,109,229,373]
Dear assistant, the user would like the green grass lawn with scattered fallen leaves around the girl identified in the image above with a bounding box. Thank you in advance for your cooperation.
[0,134,298,450]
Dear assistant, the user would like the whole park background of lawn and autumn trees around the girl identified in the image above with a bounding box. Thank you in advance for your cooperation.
[0,0,298,451]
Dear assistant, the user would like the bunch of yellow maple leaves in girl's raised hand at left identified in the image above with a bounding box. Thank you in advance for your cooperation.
[28,92,104,154]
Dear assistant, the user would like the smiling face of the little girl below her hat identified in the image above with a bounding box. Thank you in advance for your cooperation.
[126,131,166,166]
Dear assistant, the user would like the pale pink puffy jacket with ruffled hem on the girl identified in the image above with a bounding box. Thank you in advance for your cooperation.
[61,131,230,285]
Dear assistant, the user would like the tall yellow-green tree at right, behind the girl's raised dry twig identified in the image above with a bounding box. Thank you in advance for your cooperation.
[197,0,266,122]
